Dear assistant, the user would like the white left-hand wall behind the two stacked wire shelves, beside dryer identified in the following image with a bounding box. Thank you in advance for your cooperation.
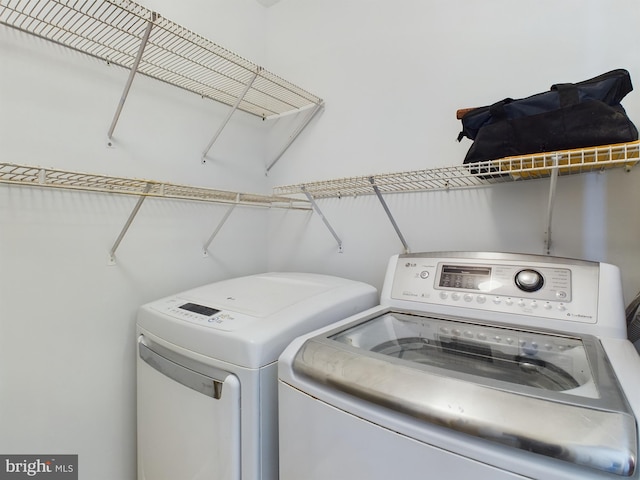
[0,0,268,480]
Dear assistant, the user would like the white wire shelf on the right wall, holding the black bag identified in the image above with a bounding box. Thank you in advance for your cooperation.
[273,141,640,198]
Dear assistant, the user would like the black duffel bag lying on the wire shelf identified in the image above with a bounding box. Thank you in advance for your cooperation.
[458,69,638,163]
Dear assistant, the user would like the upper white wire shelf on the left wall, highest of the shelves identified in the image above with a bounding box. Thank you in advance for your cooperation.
[0,0,322,118]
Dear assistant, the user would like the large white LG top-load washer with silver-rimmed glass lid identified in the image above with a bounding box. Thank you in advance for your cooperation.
[279,252,640,480]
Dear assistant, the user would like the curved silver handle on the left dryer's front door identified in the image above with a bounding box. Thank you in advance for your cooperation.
[138,335,226,399]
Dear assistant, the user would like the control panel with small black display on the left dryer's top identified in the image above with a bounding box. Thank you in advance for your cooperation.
[152,297,255,331]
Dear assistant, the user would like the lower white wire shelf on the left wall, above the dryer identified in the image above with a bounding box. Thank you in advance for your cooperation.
[0,163,311,210]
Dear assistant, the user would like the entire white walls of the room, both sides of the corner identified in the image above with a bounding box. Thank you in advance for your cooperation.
[0,0,640,480]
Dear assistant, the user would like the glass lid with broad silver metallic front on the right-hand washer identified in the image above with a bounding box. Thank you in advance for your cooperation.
[293,312,637,476]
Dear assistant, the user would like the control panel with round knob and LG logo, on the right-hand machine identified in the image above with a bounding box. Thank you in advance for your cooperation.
[391,254,599,323]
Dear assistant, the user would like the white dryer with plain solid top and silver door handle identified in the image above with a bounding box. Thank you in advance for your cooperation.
[137,273,378,480]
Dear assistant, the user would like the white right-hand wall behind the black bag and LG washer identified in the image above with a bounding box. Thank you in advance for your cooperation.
[267,0,640,301]
